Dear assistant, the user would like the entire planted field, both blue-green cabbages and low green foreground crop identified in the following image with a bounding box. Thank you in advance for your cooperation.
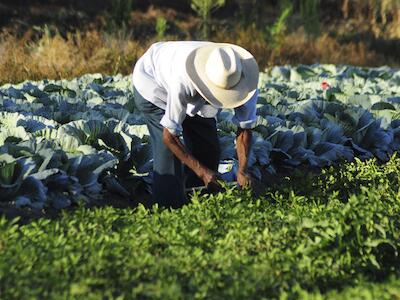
[0,64,400,299]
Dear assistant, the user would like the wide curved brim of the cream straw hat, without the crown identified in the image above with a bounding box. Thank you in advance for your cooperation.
[186,43,259,108]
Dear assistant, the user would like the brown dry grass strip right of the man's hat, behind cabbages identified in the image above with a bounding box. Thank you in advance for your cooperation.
[215,26,399,68]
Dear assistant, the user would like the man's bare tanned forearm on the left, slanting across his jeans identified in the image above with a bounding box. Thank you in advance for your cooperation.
[163,129,205,178]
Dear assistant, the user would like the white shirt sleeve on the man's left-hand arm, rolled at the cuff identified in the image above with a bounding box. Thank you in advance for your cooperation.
[160,81,187,135]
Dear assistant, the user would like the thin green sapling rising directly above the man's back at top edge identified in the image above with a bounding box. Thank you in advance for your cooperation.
[191,0,225,40]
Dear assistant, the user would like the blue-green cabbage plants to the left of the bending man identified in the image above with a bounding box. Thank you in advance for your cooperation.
[0,74,152,208]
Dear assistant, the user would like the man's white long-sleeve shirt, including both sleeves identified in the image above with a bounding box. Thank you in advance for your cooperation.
[132,41,258,135]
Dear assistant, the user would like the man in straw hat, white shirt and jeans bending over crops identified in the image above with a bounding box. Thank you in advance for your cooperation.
[132,41,258,207]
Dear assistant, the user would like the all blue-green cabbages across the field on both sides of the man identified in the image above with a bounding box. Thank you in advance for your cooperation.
[0,65,400,208]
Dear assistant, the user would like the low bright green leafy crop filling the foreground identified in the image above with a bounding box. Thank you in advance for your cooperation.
[0,157,400,299]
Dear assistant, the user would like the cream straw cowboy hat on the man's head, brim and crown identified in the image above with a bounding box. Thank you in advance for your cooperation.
[186,43,259,108]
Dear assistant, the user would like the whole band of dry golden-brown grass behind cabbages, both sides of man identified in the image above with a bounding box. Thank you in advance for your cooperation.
[0,21,399,84]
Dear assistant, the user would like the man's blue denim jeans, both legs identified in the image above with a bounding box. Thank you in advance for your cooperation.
[134,89,220,208]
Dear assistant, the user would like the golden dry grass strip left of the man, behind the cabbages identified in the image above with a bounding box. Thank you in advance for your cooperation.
[0,31,150,83]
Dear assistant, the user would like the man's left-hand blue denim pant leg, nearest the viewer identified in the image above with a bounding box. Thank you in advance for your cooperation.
[134,89,187,208]
